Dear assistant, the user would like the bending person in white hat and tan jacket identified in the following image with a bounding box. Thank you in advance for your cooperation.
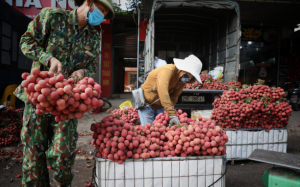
[138,55,202,126]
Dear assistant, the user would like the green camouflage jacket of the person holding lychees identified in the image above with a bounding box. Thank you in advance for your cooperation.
[15,8,100,102]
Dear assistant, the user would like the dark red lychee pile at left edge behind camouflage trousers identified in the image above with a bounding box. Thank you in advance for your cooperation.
[0,107,23,147]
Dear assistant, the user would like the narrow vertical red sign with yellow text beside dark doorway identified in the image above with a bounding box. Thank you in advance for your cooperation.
[101,32,112,97]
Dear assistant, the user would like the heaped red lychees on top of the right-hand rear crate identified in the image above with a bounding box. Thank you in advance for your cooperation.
[212,85,292,131]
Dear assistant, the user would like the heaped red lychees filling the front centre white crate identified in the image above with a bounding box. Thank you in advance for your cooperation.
[91,110,228,164]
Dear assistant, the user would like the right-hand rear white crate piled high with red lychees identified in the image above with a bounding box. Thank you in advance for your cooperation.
[212,85,292,160]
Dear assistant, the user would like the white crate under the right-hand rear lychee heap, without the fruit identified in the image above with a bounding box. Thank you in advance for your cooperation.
[224,128,287,160]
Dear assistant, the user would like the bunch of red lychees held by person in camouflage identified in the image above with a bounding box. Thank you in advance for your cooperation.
[21,68,103,122]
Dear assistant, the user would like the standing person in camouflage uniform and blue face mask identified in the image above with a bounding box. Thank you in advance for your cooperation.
[15,0,114,187]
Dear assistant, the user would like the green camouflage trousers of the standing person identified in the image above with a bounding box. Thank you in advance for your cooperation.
[21,103,78,187]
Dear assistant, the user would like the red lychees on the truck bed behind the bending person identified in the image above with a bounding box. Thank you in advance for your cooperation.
[185,74,241,90]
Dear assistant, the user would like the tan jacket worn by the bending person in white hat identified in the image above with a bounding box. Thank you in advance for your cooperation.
[142,64,195,116]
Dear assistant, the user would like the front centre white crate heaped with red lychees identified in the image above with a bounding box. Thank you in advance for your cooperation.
[91,111,228,187]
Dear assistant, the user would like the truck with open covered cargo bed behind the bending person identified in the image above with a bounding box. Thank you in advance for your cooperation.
[138,0,241,117]
